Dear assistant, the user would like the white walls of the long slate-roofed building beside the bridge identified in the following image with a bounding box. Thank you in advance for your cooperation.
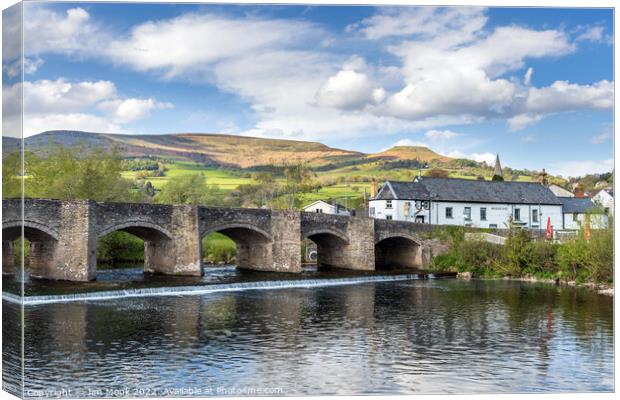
[370,200,563,229]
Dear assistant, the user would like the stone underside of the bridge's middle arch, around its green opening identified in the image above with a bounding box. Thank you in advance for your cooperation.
[200,222,273,270]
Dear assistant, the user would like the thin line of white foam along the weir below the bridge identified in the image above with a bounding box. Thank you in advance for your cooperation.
[2,274,420,305]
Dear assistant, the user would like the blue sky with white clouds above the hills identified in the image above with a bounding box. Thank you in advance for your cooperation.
[2,2,614,176]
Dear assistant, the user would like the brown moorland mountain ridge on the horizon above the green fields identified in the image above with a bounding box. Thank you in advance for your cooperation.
[3,130,453,168]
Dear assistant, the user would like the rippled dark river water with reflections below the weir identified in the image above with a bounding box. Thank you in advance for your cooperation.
[3,280,613,397]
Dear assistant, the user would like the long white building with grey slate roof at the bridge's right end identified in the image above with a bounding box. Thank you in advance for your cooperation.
[369,177,563,229]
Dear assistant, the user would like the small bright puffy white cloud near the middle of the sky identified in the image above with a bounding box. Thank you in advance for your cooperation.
[316,70,385,110]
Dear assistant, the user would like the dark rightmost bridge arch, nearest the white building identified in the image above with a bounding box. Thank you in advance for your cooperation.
[375,233,423,269]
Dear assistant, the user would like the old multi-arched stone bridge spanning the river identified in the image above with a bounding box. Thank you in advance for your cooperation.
[2,199,441,281]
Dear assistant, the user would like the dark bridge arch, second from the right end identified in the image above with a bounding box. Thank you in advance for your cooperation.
[302,228,349,268]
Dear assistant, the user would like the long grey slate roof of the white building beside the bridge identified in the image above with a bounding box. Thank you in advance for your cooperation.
[380,177,562,205]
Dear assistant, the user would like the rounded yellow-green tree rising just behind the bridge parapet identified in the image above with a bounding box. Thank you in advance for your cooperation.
[155,174,222,206]
